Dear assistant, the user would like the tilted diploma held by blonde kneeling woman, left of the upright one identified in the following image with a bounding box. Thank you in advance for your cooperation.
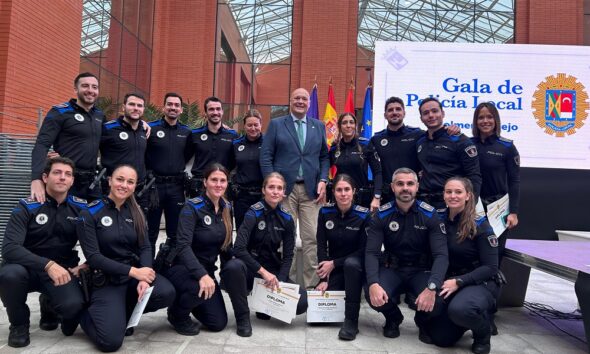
[250,278,301,323]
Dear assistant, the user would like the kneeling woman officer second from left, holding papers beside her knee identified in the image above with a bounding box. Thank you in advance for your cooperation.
[80,165,175,352]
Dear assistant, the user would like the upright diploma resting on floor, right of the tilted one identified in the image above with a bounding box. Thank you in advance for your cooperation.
[307,291,344,323]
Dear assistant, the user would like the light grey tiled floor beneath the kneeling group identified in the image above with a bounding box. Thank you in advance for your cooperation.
[0,235,587,354]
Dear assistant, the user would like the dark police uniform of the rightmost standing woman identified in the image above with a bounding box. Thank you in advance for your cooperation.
[471,135,520,257]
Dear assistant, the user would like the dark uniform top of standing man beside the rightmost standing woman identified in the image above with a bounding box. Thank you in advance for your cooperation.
[416,128,481,209]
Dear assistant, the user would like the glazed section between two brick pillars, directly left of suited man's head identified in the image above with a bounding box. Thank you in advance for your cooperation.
[214,0,293,126]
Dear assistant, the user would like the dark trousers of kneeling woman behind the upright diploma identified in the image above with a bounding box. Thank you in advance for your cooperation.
[328,256,364,321]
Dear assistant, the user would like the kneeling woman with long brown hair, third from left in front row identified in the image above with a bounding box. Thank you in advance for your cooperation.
[163,163,237,336]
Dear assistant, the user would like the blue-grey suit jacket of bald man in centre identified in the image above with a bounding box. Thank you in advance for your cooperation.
[260,115,330,199]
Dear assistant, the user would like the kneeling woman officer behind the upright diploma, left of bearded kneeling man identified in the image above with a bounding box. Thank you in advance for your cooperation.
[316,174,369,340]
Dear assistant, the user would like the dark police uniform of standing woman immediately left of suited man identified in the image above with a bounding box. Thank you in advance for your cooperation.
[230,135,264,229]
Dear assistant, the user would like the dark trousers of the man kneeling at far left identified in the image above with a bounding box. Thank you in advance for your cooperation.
[0,264,84,326]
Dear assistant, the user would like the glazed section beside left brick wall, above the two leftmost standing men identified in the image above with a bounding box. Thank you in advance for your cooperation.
[80,0,155,117]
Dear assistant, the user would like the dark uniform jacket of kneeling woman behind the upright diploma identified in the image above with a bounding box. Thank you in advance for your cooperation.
[316,204,370,268]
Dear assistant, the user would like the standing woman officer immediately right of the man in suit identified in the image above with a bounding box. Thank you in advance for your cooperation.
[329,113,383,210]
